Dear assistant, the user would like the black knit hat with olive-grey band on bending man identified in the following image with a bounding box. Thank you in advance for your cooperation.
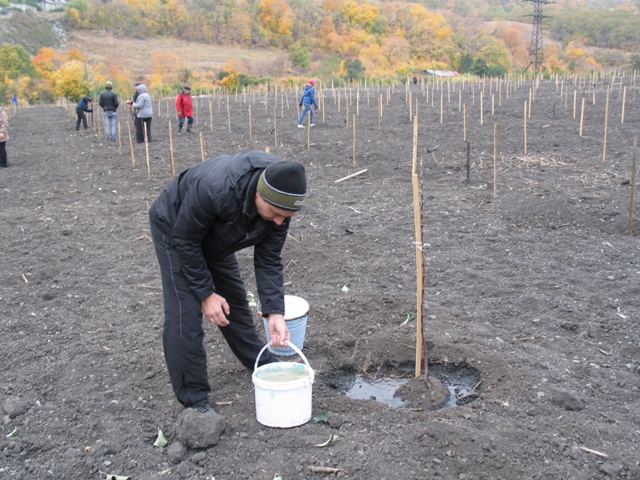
[257,160,307,212]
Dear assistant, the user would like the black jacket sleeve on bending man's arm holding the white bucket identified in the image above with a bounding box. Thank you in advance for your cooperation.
[253,218,290,316]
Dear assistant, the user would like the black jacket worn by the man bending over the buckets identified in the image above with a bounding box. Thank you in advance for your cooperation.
[149,150,290,315]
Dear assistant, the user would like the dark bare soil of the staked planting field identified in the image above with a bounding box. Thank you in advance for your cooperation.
[0,78,640,480]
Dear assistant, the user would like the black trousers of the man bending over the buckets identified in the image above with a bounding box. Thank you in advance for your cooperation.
[151,221,276,406]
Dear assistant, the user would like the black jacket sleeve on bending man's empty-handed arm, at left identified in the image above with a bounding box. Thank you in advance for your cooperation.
[173,181,217,301]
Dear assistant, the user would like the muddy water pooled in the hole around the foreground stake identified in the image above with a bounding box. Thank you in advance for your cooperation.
[338,364,480,410]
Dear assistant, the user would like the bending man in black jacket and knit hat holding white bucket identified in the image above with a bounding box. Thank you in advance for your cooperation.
[149,151,307,413]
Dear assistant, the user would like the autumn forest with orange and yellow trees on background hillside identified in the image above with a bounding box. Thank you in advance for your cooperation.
[0,0,640,102]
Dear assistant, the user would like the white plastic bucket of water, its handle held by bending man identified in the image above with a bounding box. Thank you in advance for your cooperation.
[252,342,314,428]
